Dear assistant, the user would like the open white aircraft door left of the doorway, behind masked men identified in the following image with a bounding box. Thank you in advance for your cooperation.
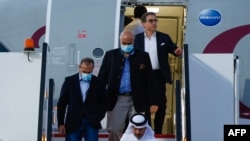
[45,0,121,104]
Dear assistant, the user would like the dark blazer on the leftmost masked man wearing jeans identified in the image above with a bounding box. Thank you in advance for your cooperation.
[57,73,107,133]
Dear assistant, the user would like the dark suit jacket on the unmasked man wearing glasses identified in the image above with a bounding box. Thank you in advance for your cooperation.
[134,31,177,84]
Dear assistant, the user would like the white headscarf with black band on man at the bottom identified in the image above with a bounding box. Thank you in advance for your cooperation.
[120,113,156,141]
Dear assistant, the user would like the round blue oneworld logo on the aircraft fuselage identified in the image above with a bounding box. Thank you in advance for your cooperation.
[199,9,221,26]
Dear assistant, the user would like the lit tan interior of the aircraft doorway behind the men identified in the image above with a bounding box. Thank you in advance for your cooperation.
[124,5,186,134]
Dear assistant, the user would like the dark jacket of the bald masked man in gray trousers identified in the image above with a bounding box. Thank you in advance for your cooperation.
[98,48,157,112]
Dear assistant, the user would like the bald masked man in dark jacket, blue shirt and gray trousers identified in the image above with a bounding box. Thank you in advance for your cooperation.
[98,30,157,141]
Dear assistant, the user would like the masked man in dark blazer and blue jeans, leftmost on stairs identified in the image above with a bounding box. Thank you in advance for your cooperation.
[57,58,106,141]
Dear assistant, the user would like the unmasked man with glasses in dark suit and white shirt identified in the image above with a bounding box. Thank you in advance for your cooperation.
[135,12,182,134]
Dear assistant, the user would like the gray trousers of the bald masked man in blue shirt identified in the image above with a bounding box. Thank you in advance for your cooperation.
[107,96,135,141]
